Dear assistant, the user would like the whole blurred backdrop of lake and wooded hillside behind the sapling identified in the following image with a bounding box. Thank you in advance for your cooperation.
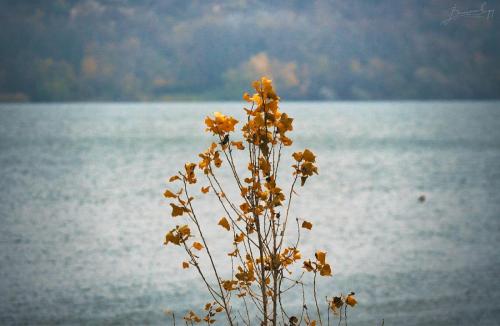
[0,0,500,325]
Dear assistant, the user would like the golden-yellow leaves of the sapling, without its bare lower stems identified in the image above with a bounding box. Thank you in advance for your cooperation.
[160,77,356,326]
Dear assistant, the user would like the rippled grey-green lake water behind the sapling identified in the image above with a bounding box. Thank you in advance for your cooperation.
[0,102,500,325]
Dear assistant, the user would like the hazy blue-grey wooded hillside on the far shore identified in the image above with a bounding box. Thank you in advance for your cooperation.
[0,0,500,101]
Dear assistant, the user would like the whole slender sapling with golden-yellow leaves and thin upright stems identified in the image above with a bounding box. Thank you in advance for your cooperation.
[164,77,356,325]
